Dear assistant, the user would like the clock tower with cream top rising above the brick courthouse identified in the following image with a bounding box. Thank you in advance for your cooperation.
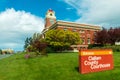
[45,9,56,29]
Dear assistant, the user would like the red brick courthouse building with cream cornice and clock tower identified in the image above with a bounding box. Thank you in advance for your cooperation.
[42,9,101,49]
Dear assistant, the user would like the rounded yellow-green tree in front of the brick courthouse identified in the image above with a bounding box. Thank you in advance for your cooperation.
[45,30,81,51]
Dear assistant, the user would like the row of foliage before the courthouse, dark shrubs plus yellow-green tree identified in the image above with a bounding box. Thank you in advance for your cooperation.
[24,30,82,54]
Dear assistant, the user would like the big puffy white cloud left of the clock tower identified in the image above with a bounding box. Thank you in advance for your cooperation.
[0,8,44,50]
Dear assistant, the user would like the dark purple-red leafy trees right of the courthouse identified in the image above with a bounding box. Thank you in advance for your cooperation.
[95,28,120,45]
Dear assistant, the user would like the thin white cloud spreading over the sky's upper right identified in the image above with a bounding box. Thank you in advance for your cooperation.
[65,0,120,27]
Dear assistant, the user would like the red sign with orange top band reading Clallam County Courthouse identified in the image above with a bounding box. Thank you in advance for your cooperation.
[79,49,113,74]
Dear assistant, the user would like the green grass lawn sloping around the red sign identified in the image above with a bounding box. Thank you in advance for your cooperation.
[0,52,120,80]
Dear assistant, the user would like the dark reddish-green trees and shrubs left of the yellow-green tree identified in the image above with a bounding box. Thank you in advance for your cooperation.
[24,33,47,55]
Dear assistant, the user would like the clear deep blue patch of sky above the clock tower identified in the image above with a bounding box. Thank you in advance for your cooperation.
[0,0,78,20]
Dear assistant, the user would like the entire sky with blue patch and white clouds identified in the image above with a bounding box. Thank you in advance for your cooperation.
[0,0,120,50]
